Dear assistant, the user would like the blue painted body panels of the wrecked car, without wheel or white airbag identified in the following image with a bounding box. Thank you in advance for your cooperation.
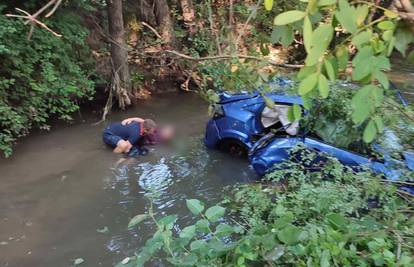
[204,78,414,195]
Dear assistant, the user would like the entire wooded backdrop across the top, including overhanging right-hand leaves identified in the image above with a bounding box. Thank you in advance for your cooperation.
[0,0,414,156]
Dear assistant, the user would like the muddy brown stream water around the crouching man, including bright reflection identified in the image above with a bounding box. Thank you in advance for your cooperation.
[0,94,255,267]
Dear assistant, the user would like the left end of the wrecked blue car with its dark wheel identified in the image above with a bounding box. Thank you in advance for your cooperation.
[204,79,302,156]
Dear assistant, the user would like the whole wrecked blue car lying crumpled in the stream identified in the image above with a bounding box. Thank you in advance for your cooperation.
[205,79,414,194]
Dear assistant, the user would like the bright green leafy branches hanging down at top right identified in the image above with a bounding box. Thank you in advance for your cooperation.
[268,0,414,143]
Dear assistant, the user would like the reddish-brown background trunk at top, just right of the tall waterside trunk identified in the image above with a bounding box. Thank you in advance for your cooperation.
[154,0,177,47]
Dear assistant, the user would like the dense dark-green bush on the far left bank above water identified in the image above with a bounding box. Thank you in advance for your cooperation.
[0,8,94,156]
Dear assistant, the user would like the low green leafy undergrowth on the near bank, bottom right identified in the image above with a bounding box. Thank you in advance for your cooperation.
[121,150,414,266]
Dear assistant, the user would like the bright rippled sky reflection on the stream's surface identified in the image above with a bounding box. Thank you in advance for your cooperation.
[105,135,255,258]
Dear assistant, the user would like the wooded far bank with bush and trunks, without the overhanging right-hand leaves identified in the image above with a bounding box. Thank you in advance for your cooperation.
[0,0,289,156]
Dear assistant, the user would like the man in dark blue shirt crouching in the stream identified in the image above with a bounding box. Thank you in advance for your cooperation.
[103,118,157,154]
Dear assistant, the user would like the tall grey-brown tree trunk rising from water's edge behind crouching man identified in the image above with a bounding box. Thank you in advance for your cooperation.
[106,0,131,109]
